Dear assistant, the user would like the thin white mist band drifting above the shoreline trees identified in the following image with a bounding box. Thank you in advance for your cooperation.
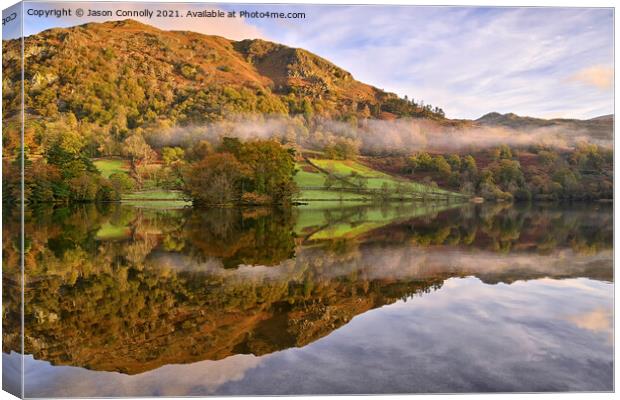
[147,116,612,154]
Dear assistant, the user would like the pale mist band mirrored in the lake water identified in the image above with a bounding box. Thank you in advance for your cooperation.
[147,244,613,283]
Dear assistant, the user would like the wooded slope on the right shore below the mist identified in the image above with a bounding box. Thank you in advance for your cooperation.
[401,143,613,201]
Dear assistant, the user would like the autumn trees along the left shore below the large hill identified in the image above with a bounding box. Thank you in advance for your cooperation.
[2,131,297,205]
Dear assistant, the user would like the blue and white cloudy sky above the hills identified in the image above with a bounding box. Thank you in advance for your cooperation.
[5,3,614,119]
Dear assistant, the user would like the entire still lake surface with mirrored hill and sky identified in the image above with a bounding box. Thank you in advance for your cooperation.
[3,204,613,397]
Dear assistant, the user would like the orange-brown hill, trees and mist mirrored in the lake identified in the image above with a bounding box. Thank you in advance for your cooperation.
[3,205,613,374]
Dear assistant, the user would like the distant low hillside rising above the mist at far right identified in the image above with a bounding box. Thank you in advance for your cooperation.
[474,112,614,141]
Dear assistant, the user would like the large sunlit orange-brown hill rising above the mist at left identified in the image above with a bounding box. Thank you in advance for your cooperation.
[3,20,443,139]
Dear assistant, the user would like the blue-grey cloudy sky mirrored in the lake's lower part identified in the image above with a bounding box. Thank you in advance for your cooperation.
[17,277,613,397]
